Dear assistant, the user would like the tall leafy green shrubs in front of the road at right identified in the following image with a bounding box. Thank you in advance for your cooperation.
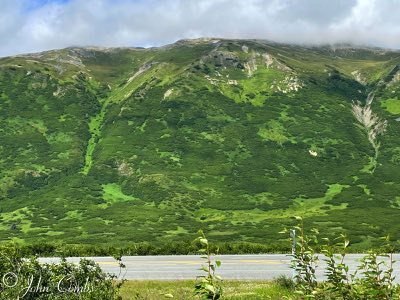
[282,217,400,300]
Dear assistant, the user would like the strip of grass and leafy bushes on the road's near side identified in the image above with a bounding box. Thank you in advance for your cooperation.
[0,227,400,300]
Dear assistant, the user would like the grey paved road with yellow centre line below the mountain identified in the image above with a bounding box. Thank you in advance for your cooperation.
[40,254,400,282]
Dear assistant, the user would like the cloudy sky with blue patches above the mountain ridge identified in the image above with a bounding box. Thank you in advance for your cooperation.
[0,0,400,56]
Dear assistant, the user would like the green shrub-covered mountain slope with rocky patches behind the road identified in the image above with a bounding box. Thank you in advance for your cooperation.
[0,39,400,248]
